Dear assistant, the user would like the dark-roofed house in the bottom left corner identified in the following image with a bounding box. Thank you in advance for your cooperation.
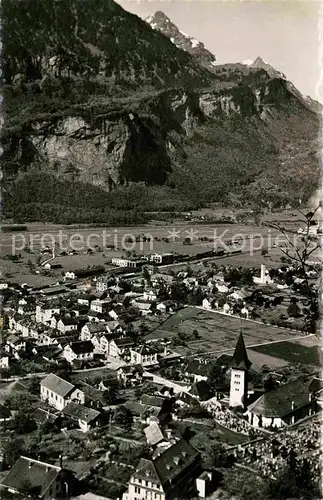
[1,456,77,500]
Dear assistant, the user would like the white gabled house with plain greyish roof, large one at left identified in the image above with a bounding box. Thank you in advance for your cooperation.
[40,373,84,411]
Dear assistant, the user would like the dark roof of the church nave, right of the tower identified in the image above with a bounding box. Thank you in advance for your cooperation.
[248,379,311,418]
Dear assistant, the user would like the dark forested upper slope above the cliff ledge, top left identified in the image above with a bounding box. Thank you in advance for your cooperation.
[2,0,215,91]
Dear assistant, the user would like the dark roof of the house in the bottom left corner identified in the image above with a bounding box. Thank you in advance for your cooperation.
[2,456,62,496]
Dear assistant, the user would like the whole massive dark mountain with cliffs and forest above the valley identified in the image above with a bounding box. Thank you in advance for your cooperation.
[1,0,320,224]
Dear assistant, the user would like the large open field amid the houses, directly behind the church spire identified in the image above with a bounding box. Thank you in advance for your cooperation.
[146,307,317,368]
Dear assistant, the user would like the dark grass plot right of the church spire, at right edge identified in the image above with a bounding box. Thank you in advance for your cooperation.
[253,341,321,366]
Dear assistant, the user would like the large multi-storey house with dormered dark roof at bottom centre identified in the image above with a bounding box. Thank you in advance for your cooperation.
[122,439,201,500]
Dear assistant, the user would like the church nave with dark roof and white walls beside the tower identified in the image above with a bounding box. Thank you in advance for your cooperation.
[246,379,319,428]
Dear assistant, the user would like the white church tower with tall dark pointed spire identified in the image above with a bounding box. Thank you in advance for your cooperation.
[230,332,251,407]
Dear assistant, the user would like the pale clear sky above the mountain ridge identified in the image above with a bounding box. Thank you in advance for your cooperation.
[117,0,323,102]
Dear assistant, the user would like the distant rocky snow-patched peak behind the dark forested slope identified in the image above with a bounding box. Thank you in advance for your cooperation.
[146,11,216,70]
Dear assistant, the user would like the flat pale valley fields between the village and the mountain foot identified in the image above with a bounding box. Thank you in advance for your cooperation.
[0,209,322,285]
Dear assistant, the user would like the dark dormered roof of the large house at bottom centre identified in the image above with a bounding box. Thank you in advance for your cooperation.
[135,439,199,492]
